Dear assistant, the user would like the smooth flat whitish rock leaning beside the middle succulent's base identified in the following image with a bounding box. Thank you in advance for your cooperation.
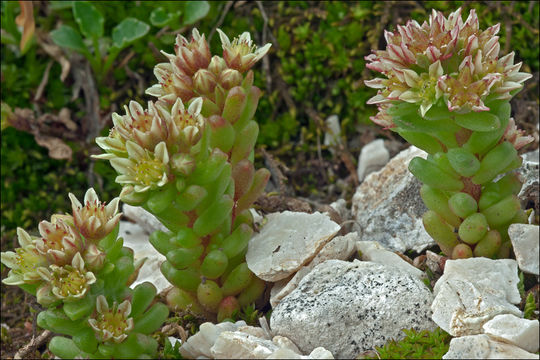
[246,211,340,281]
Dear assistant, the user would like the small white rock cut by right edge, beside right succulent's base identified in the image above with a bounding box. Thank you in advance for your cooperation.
[508,224,540,275]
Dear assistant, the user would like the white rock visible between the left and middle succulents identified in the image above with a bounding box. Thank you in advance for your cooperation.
[118,221,171,293]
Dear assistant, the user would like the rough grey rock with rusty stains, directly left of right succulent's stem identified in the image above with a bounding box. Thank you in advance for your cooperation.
[351,146,435,253]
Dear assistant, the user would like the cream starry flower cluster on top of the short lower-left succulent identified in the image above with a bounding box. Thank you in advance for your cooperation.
[1,188,121,306]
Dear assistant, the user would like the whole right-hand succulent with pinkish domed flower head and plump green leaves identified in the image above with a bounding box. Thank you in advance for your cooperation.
[365,9,533,258]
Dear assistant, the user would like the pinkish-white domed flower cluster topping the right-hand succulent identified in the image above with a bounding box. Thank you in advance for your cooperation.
[365,9,531,122]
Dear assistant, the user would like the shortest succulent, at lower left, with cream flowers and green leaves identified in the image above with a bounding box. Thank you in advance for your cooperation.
[1,189,169,359]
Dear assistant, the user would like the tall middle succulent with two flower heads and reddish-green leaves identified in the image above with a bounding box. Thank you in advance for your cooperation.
[96,29,270,321]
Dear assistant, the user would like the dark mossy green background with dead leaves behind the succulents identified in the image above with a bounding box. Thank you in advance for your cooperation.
[1,1,539,246]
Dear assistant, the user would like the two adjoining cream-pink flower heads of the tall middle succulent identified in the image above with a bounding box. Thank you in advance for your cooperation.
[95,29,270,194]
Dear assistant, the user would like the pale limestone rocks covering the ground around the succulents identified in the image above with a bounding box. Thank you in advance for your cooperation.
[112,141,539,358]
